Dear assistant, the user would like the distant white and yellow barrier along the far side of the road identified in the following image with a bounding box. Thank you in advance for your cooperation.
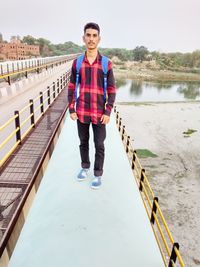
[0,54,78,85]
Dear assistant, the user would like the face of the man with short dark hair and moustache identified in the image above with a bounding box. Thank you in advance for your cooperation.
[83,29,101,50]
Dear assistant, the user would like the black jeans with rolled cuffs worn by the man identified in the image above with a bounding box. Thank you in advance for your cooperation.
[77,120,106,176]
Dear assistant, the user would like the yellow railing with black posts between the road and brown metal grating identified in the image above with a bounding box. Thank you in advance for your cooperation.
[0,70,71,167]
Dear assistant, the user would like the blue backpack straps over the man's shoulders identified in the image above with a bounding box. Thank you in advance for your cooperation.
[74,54,109,102]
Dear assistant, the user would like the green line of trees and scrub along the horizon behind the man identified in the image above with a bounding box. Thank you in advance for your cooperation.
[9,35,200,71]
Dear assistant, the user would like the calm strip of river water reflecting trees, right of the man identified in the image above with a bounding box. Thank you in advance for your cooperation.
[116,79,200,102]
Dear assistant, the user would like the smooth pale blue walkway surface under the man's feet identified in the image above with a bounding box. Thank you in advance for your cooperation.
[9,111,164,267]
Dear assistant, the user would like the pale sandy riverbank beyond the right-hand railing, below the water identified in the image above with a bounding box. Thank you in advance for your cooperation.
[117,102,200,267]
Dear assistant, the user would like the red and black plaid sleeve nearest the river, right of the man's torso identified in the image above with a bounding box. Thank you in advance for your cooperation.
[104,60,116,116]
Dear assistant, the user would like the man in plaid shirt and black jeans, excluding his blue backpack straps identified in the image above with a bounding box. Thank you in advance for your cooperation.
[68,22,116,189]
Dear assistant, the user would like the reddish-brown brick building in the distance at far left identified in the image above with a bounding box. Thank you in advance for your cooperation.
[0,34,40,61]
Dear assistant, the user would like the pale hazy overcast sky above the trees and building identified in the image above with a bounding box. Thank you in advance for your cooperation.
[0,0,200,53]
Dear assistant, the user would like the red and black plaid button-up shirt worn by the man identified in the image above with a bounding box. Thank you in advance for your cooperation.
[68,53,116,124]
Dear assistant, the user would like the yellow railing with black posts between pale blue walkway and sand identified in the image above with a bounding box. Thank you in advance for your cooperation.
[114,106,185,267]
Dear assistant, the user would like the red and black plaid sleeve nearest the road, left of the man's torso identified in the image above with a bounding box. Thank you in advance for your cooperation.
[68,59,76,113]
